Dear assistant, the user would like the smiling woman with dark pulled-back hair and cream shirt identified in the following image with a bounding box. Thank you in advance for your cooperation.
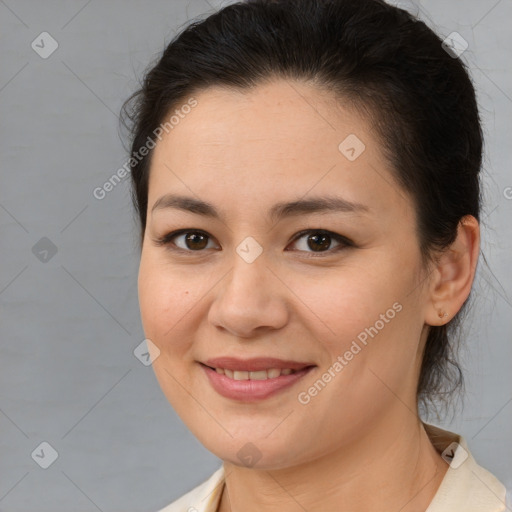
[121,0,505,512]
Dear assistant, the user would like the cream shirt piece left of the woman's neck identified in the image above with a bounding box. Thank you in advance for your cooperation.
[158,466,224,512]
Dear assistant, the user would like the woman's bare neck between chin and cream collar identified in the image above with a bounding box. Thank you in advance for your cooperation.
[218,414,448,512]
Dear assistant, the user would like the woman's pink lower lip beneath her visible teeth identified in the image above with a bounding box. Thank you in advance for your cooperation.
[200,363,314,402]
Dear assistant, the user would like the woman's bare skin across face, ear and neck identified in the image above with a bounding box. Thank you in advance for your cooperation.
[138,80,479,512]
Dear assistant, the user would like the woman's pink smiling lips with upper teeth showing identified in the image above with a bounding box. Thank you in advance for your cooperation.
[200,357,315,402]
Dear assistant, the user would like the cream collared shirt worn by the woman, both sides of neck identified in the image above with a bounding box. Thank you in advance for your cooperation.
[158,423,508,512]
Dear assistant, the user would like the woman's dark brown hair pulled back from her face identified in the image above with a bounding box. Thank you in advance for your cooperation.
[122,0,482,416]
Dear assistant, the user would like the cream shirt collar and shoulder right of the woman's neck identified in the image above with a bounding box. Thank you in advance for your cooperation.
[424,424,506,512]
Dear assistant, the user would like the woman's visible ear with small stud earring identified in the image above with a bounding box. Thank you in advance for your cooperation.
[425,215,480,326]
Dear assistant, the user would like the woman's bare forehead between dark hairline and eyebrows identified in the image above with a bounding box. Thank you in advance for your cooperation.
[148,80,403,219]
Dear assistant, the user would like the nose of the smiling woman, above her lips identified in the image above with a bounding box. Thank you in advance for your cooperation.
[208,249,290,338]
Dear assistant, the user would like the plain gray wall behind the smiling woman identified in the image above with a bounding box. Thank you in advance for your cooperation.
[0,0,512,512]
